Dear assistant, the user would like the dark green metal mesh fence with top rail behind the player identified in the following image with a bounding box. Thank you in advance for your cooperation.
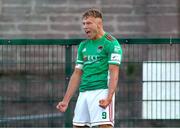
[0,38,180,127]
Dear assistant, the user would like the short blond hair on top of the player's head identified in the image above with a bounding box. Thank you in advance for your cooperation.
[82,8,103,19]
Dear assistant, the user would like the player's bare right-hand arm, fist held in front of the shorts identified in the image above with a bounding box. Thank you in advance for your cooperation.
[99,65,119,108]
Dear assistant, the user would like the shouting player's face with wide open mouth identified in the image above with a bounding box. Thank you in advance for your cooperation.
[82,17,99,39]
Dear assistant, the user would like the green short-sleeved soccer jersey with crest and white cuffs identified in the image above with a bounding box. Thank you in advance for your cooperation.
[76,33,122,92]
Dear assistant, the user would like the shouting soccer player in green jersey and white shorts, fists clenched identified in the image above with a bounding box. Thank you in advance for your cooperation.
[57,9,122,128]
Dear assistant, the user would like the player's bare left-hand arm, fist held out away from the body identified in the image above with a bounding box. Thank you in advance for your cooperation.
[56,68,82,112]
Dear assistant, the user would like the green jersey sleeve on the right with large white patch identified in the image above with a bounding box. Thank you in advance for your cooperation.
[108,40,122,65]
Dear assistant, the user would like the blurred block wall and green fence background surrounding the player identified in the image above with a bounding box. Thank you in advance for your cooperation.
[0,0,180,127]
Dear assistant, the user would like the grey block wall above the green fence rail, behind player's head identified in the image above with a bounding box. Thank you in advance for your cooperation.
[0,0,180,39]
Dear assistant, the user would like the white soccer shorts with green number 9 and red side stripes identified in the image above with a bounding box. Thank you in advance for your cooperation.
[73,89,115,127]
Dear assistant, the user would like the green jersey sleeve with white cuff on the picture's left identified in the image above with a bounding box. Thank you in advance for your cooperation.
[75,43,84,69]
